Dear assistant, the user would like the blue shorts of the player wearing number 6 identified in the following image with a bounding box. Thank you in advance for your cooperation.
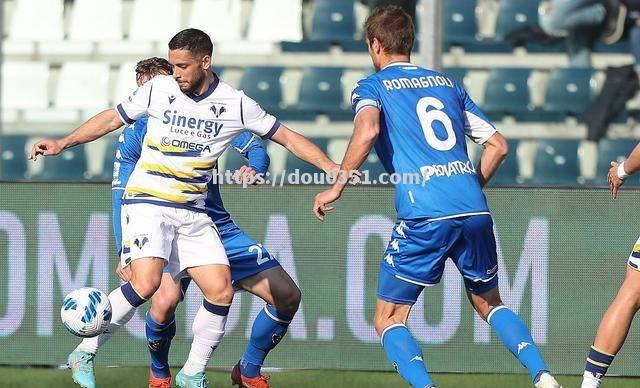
[378,214,498,304]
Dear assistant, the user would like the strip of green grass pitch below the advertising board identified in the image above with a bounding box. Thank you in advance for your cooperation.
[0,367,640,388]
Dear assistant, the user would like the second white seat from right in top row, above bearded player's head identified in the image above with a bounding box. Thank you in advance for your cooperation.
[189,0,242,42]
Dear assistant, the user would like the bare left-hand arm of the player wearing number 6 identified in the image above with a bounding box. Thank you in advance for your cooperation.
[313,108,380,221]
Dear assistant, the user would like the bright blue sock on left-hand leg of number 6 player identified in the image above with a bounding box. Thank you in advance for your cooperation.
[381,324,433,388]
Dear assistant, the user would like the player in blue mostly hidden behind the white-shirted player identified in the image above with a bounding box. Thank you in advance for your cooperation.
[72,58,301,388]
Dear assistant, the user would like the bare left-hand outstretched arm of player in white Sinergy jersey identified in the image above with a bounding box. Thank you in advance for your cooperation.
[29,109,124,160]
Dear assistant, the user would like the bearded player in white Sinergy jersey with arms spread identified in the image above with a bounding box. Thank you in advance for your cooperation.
[29,29,337,388]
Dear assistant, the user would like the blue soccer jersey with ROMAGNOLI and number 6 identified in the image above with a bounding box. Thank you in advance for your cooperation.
[351,62,496,220]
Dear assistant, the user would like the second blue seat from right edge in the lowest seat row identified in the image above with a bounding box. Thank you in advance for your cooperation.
[532,140,583,185]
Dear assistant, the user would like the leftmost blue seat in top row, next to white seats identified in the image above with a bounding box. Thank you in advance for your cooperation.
[309,0,356,43]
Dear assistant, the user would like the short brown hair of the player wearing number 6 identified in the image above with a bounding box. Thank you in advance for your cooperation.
[364,5,415,55]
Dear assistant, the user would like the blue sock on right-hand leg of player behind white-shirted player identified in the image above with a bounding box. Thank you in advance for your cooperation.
[240,305,293,377]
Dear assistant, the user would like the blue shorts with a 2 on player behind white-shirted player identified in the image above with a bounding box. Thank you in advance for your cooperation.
[164,222,280,284]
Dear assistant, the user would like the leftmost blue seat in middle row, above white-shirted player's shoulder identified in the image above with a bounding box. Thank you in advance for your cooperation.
[240,66,283,112]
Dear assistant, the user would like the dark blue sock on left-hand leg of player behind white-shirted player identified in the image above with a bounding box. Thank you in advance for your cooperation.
[145,312,176,378]
